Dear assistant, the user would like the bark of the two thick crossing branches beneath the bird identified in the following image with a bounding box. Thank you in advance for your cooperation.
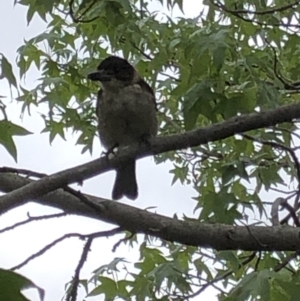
[0,103,300,251]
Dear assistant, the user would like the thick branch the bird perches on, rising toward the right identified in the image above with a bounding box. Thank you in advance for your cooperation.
[0,99,300,213]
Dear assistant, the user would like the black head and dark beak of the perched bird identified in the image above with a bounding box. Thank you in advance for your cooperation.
[88,56,136,85]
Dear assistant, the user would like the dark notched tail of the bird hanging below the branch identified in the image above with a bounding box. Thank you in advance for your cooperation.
[112,160,138,200]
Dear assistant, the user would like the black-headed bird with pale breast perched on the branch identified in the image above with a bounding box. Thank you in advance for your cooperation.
[88,55,158,200]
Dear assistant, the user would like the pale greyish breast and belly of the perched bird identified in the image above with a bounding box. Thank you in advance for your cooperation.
[97,85,157,148]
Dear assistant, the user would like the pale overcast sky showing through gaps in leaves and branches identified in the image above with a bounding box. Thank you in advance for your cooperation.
[0,0,220,301]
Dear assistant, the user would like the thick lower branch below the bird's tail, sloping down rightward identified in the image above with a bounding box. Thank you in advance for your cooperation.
[0,173,300,251]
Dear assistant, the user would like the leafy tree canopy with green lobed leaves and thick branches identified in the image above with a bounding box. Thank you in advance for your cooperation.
[0,0,300,301]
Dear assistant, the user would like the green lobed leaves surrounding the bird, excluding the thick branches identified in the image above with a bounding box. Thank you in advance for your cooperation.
[0,0,300,301]
